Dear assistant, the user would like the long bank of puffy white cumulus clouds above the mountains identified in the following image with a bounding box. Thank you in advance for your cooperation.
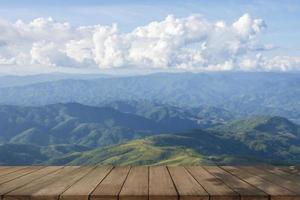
[0,14,300,71]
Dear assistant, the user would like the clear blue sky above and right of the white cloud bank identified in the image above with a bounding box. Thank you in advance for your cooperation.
[0,0,300,73]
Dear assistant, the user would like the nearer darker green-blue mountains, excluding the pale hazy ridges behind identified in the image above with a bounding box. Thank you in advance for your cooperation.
[0,101,300,165]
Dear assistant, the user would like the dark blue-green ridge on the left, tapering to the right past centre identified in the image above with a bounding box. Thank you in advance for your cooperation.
[0,103,184,147]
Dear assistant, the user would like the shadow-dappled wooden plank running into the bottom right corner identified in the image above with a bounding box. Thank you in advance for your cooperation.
[222,166,300,200]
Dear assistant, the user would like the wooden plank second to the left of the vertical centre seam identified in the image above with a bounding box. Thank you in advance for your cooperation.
[90,166,130,200]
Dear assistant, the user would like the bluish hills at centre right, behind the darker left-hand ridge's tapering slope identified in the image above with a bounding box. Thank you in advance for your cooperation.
[104,100,235,128]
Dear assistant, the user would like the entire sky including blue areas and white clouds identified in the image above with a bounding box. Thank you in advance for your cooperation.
[0,0,300,74]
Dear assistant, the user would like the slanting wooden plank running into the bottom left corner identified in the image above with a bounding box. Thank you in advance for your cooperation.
[0,167,62,196]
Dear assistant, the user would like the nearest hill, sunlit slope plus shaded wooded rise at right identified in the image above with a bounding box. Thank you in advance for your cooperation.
[48,117,300,165]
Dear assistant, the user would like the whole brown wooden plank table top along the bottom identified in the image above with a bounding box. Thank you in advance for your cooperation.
[0,166,300,200]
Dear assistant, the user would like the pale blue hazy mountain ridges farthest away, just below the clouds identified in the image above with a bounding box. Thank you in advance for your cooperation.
[0,72,300,122]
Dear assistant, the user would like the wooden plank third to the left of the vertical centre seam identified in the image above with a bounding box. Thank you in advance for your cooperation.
[60,166,113,200]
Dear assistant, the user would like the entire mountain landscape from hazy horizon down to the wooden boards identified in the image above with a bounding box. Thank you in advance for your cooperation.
[0,72,300,165]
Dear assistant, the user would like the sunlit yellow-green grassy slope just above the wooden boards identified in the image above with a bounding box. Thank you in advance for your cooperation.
[49,139,205,165]
